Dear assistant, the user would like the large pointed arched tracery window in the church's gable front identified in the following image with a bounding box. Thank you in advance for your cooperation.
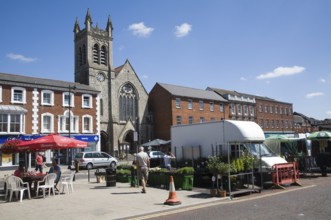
[119,83,138,121]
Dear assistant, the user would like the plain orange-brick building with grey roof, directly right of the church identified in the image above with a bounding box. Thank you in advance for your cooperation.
[148,83,229,140]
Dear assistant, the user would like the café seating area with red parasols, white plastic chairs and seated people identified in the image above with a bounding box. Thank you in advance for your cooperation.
[0,134,87,202]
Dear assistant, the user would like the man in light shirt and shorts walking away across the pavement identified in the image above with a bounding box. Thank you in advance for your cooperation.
[135,147,150,193]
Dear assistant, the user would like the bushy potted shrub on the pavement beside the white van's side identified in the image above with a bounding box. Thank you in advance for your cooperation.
[206,156,231,197]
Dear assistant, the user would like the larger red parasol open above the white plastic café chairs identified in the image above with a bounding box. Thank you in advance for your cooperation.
[17,134,87,151]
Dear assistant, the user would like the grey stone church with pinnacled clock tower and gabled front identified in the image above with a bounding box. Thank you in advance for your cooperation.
[74,9,151,156]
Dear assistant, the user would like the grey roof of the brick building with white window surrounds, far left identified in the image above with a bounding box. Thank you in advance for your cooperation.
[0,72,100,94]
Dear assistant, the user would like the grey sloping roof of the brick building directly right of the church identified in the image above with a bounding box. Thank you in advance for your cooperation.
[157,83,228,102]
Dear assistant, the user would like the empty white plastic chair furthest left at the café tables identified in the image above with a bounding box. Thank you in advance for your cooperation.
[6,176,31,202]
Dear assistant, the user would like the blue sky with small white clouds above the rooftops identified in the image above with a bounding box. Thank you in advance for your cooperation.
[0,0,331,119]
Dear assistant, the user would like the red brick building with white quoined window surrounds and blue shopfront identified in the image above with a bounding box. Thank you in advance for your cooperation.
[0,73,100,166]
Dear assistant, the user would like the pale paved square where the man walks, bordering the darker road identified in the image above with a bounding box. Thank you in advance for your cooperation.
[0,163,322,220]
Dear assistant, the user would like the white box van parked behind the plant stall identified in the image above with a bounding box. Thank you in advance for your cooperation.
[171,120,287,172]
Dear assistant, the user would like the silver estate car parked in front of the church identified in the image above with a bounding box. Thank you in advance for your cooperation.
[74,151,117,169]
